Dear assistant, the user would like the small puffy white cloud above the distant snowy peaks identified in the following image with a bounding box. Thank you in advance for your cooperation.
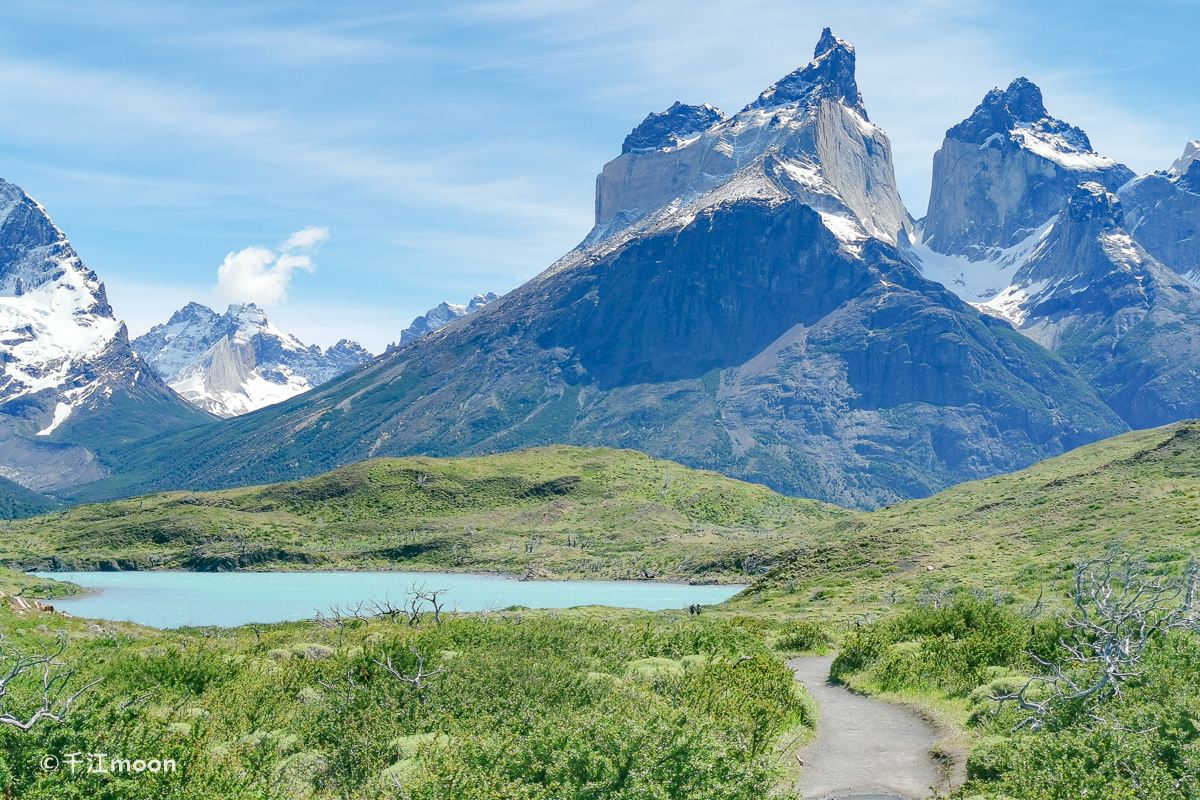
[216,228,329,306]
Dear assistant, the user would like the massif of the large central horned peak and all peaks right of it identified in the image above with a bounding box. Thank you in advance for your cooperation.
[2,29,1200,507]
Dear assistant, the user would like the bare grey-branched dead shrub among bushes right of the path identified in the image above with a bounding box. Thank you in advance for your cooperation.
[992,551,1200,730]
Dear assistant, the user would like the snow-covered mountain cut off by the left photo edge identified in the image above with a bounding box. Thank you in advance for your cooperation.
[0,180,209,491]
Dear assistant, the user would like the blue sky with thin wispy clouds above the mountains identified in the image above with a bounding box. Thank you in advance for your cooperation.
[0,0,1200,350]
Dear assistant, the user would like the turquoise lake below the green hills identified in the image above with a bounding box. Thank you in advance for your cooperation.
[37,572,743,627]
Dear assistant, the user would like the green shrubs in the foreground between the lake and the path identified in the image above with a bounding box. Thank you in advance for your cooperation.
[0,585,812,800]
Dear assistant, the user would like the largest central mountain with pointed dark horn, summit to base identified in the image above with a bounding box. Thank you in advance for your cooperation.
[77,34,1124,507]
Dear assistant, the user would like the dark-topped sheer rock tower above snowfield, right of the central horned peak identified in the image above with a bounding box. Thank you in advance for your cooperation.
[922,78,1133,259]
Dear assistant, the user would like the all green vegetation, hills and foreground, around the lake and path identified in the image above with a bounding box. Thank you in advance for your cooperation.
[0,423,1200,800]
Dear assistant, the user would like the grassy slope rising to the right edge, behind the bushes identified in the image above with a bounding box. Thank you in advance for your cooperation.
[734,422,1200,618]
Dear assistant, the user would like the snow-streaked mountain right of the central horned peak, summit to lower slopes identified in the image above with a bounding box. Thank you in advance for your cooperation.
[907,78,1200,427]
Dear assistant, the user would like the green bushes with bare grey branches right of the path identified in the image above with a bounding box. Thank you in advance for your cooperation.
[833,553,1200,800]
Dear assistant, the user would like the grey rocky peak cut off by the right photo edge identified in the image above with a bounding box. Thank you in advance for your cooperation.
[1121,142,1200,287]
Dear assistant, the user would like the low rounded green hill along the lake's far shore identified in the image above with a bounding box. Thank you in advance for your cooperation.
[0,447,845,581]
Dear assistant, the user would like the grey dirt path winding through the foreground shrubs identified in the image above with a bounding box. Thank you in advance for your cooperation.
[788,656,946,800]
